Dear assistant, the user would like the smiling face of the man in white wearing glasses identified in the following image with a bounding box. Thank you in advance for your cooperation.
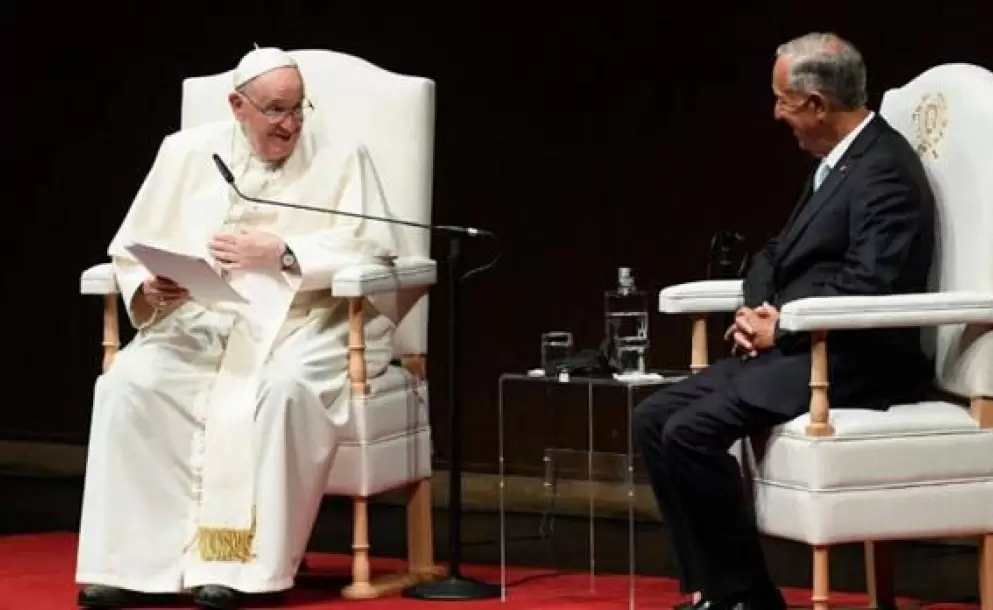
[228,68,307,162]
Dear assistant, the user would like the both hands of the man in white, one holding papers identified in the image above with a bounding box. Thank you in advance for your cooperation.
[141,231,286,309]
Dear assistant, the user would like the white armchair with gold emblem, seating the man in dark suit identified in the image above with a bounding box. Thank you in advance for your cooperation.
[660,64,993,610]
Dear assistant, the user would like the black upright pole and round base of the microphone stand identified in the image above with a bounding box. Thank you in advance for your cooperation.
[402,232,500,601]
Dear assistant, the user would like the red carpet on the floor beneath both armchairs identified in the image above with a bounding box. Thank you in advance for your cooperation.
[0,534,978,610]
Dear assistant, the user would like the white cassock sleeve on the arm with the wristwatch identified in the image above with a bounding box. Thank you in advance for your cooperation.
[286,149,396,292]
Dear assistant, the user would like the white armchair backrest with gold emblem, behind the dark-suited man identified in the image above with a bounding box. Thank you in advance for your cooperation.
[880,64,993,396]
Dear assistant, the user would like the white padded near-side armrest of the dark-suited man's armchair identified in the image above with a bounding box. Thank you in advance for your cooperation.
[779,292,993,331]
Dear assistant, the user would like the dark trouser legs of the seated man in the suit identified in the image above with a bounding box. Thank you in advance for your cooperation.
[633,349,810,599]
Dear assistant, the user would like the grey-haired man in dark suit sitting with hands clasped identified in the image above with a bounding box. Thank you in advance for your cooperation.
[634,33,934,610]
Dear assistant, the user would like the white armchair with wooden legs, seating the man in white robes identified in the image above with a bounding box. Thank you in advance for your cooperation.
[80,50,440,598]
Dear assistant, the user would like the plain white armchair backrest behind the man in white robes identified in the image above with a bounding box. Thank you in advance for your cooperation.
[181,50,435,357]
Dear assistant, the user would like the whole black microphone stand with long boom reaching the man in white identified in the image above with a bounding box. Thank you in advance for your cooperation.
[212,154,500,601]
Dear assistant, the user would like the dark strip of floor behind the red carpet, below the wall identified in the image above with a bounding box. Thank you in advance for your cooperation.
[0,474,978,603]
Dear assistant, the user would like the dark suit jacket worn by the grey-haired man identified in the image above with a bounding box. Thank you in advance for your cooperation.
[744,116,935,374]
